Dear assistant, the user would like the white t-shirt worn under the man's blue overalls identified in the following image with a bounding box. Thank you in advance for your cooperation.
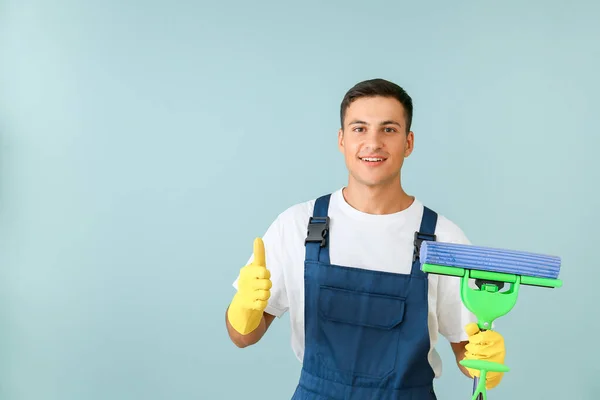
[233,189,476,377]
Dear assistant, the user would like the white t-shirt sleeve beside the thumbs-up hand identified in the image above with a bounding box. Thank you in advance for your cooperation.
[233,217,289,318]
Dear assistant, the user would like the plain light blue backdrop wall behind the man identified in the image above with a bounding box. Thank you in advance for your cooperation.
[0,0,600,400]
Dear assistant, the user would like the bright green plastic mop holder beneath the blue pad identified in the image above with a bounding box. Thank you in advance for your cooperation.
[421,263,562,400]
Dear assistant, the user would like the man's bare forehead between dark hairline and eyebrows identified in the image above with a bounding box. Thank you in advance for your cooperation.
[344,96,405,124]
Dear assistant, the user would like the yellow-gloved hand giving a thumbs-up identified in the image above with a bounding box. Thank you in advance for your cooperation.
[227,238,272,335]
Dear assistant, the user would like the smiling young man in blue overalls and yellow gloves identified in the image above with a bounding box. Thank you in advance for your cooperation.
[226,79,505,400]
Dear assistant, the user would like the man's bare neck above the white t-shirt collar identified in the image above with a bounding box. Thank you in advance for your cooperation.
[342,179,415,215]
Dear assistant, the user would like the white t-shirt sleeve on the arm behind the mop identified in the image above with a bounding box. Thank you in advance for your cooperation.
[437,223,477,343]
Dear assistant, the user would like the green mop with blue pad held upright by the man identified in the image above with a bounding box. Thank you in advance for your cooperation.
[419,241,562,400]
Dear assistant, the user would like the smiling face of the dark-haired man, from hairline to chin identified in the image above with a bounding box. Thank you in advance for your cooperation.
[338,96,414,187]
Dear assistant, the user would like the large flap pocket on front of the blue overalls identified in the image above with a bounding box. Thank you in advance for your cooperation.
[316,286,405,378]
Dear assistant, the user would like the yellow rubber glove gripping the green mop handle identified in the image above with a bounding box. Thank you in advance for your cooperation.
[465,323,506,389]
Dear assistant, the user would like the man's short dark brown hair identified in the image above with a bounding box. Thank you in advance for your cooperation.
[340,78,413,132]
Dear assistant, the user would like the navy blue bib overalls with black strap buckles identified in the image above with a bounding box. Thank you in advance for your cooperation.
[292,194,437,400]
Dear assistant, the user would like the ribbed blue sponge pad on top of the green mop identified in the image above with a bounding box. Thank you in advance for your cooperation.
[419,241,560,279]
